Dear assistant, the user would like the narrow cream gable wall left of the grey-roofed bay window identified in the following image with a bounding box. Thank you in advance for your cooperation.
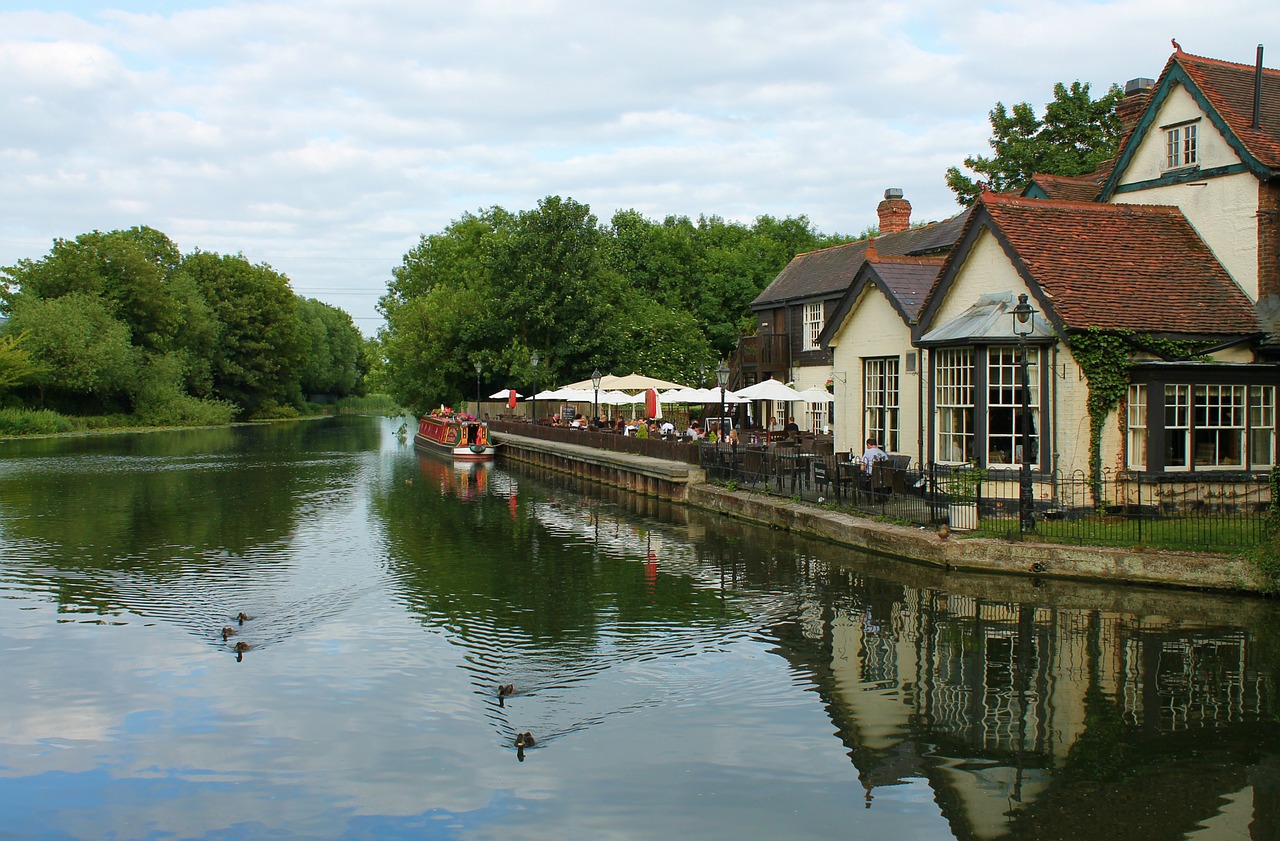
[832,284,920,461]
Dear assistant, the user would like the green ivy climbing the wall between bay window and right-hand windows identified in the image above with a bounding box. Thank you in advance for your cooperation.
[1064,328,1206,499]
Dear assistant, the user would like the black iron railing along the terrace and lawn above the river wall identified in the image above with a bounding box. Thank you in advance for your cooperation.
[698,443,1271,549]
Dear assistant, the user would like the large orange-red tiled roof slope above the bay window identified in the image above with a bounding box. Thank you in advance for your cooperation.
[945,193,1258,335]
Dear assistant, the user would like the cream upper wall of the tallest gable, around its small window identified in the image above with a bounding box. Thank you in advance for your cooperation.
[1111,84,1258,301]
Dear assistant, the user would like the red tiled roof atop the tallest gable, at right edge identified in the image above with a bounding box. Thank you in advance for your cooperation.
[1172,51,1280,172]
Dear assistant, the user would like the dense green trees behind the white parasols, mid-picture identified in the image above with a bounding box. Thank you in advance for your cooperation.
[379,196,849,410]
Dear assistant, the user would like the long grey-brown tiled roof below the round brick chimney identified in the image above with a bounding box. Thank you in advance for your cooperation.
[751,209,969,308]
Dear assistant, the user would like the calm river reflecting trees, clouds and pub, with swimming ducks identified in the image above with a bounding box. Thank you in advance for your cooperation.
[0,417,1280,841]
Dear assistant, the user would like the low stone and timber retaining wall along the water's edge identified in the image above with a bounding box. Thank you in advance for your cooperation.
[497,434,1272,594]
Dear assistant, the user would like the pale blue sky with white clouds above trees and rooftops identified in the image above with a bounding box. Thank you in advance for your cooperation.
[0,0,1280,335]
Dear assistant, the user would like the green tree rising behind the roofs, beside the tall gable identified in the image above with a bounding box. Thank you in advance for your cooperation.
[946,82,1124,205]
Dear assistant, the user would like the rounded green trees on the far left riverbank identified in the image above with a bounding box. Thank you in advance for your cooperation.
[0,227,367,425]
